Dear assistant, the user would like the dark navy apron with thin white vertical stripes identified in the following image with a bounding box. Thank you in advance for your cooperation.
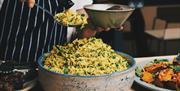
[0,0,67,63]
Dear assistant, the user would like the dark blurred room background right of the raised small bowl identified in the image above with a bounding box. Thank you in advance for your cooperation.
[95,0,180,57]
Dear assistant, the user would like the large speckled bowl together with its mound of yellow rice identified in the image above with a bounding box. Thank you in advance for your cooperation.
[38,38,136,91]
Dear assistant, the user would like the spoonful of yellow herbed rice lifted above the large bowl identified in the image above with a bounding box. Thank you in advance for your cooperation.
[54,10,87,28]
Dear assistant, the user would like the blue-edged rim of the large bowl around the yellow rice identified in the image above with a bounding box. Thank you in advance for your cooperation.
[38,52,136,78]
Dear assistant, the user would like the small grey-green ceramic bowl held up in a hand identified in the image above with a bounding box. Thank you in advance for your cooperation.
[84,4,134,28]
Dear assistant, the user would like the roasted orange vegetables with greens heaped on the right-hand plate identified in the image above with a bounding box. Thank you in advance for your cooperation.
[136,59,180,91]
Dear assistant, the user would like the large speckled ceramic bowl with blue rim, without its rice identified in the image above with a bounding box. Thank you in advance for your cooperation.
[38,52,136,91]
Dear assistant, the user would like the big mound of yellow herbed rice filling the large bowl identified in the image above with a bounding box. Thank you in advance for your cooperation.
[44,38,130,76]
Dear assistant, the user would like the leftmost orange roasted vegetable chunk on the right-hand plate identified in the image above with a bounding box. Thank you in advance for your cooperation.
[141,71,154,83]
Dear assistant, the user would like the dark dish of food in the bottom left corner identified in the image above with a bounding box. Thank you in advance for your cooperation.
[0,60,37,91]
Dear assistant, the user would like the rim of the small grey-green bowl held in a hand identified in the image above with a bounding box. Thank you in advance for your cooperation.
[84,4,135,13]
